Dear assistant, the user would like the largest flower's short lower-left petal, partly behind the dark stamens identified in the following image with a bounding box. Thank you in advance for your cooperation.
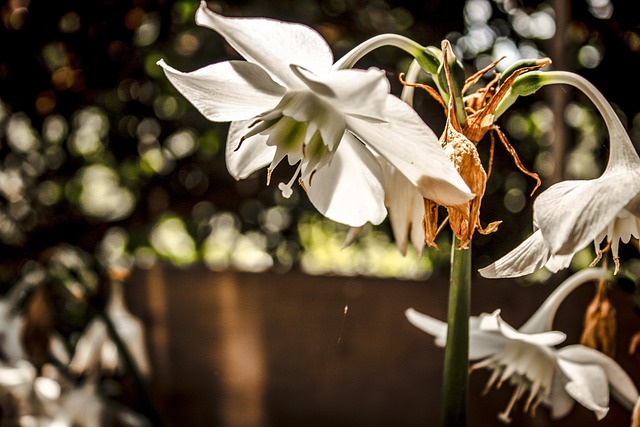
[225,120,276,179]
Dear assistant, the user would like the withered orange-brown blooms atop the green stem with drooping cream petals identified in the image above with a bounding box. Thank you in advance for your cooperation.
[383,44,550,253]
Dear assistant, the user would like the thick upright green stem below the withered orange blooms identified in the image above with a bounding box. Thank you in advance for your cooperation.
[440,237,471,427]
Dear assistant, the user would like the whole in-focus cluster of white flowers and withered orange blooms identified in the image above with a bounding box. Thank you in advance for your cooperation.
[158,2,640,422]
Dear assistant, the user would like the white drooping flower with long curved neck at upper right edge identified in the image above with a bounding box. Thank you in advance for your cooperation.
[480,71,640,278]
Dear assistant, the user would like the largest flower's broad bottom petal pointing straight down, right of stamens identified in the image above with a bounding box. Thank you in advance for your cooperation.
[303,133,387,227]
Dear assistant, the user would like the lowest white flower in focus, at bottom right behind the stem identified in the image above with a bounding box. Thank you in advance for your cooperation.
[406,269,638,422]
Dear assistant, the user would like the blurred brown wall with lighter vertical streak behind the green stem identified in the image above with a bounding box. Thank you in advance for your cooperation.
[127,266,640,427]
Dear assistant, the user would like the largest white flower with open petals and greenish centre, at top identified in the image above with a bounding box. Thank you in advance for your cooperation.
[159,2,473,226]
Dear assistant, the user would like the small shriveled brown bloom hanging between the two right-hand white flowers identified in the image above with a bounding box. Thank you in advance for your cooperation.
[580,280,616,357]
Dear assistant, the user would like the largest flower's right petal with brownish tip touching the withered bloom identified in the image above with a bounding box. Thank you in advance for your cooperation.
[347,95,473,205]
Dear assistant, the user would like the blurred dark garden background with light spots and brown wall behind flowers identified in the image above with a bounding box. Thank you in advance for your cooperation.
[0,0,640,426]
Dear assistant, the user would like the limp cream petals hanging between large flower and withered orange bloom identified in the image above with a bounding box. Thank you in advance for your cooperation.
[378,159,425,255]
